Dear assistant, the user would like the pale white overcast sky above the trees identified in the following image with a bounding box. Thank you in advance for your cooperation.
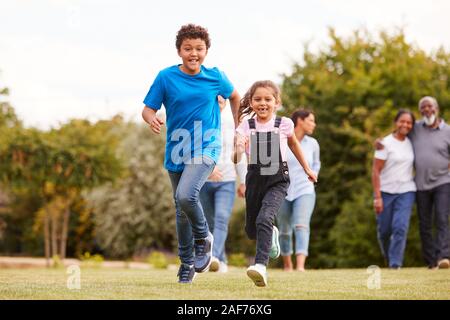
[0,0,450,129]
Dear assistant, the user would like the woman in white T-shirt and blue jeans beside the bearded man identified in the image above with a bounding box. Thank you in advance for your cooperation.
[372,110,416,269]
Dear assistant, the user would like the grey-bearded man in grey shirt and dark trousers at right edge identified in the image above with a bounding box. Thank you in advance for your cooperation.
[410,96,450,269]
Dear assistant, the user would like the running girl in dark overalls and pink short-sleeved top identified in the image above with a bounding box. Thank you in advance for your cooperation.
[233,81,317,287]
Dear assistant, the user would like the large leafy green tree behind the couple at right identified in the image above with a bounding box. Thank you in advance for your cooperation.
[282,29,450,267]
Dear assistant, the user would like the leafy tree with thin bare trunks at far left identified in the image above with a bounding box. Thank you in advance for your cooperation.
[0,119,122,262]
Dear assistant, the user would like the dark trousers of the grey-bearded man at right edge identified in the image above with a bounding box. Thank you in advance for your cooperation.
[417,183,450,267]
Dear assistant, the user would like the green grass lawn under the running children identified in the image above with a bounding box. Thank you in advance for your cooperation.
[0,268,450,300]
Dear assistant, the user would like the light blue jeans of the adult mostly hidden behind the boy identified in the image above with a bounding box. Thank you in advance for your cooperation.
[200,181,236,263]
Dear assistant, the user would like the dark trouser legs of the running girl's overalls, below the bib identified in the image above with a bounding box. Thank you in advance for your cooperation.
[245,162,289,265]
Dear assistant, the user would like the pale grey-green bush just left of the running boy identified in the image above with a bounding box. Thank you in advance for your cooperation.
[88,124,176,258]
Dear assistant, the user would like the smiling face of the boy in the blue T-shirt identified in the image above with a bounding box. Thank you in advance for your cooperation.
[178,39,208,75]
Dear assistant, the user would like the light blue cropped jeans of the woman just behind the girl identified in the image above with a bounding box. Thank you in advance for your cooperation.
[277,193,316,256]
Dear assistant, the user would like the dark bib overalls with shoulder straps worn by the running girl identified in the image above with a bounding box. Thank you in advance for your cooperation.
[245,117,289,265]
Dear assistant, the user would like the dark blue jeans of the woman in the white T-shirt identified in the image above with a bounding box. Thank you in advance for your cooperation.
[377,192,416,267]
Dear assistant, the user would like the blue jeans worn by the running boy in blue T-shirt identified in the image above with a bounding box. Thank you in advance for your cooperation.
[169,157,215,265]
